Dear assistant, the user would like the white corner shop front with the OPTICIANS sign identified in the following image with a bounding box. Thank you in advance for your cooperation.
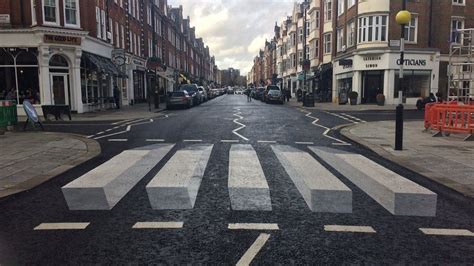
[333,50,439,104]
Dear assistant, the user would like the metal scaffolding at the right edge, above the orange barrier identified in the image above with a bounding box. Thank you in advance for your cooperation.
[448,29,474,104]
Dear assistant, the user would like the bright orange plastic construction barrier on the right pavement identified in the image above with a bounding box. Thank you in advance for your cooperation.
[425,103,474,140]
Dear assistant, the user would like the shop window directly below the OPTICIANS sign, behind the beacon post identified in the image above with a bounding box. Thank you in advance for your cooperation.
[393,70,431,98]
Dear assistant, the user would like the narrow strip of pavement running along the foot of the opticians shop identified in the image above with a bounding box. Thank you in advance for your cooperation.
[287,97,416,112]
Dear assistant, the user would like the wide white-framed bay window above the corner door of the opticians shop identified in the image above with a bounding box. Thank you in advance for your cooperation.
[358,15,388,43]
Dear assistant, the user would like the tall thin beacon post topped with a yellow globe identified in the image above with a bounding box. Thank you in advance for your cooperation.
[395,0,411,151]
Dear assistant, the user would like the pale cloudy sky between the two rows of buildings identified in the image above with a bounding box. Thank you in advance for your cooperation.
[168,0,294,75]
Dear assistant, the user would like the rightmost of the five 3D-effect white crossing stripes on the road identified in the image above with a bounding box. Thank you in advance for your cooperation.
[309,146,437,216]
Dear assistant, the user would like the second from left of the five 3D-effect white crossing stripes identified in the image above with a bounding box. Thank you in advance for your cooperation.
[146,144,214,210]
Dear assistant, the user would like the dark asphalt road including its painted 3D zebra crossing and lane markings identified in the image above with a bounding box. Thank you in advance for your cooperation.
[0,95,474,265]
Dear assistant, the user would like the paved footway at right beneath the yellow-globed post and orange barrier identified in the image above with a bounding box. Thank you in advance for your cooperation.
[341,120,474,198]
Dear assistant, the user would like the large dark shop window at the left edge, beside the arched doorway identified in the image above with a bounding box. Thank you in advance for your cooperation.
[0,48,41,104]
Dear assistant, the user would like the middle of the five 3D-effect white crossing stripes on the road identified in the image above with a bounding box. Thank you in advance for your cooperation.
[228,144,272,211]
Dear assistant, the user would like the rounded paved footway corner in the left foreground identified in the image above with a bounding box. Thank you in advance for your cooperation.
[0,132,101,198]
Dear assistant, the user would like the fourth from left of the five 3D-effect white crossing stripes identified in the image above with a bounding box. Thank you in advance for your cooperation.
[272,145,352,213]
